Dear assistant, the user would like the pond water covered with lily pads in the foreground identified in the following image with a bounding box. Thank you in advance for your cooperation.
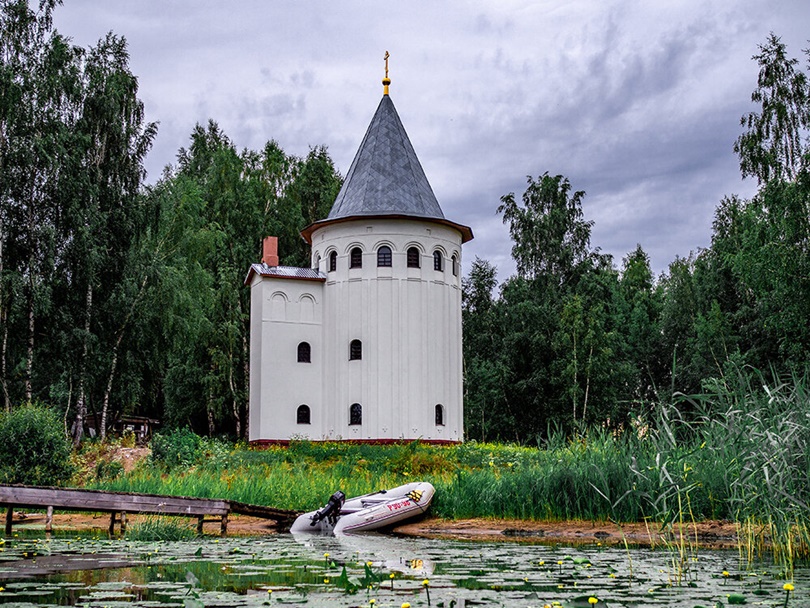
[0,534,810,608]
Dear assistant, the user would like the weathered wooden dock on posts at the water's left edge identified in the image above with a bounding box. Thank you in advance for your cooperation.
[0,485,298,536]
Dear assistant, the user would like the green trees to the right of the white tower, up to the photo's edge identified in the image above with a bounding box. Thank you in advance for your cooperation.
[463,34,810,443]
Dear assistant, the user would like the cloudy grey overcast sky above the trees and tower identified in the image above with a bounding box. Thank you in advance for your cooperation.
[55,0,810,280]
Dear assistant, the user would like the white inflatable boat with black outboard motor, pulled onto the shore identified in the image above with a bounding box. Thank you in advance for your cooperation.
[290,481,436,534]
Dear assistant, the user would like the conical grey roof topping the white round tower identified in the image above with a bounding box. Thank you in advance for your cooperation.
[327,95,444,221]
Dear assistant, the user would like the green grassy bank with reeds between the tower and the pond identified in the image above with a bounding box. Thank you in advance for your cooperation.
[83,368,810,561]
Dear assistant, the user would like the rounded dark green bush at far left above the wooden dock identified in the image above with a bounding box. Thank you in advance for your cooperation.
[0,405,73,486]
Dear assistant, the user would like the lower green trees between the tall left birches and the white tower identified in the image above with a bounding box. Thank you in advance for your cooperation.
[137,121,341,438]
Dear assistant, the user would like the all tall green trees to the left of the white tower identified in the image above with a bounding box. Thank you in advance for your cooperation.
[0,0,341,443]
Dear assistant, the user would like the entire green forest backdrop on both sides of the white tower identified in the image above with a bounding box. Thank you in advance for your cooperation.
[0,0,810,443]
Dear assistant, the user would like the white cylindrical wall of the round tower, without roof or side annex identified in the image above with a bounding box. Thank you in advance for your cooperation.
[312,218,463,441]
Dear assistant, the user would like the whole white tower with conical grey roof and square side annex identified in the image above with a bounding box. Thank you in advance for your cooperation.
[246,64,473,443]
